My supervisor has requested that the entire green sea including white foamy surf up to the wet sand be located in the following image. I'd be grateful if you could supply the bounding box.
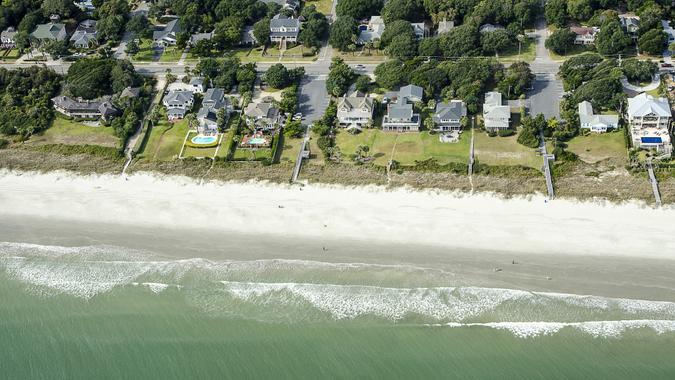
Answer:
[0,244,675,379]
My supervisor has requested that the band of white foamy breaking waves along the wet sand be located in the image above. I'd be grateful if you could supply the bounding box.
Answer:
[0,243,675,338]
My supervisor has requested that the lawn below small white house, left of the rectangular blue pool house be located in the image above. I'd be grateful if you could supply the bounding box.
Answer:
[567,130,628,164]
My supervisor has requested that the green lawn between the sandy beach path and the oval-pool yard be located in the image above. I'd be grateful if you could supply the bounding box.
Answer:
[140,119,188,161]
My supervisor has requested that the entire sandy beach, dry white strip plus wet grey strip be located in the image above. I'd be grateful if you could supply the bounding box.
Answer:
[0,172,675,301]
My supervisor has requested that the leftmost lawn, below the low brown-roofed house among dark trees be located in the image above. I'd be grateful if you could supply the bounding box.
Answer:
[30,117,119,147]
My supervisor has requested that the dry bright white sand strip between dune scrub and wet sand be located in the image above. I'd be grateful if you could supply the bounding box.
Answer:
[0,170,675,260]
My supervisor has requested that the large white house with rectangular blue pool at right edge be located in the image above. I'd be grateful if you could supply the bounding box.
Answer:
[628,93,673,154]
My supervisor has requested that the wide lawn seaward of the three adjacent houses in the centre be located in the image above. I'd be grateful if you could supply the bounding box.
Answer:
[336,129,471,165]
